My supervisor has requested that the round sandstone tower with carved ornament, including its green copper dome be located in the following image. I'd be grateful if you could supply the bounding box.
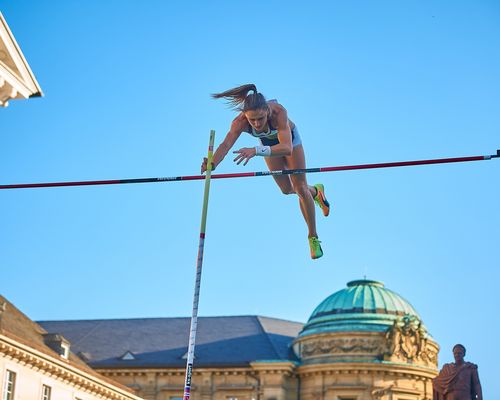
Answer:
[293,280,439,400]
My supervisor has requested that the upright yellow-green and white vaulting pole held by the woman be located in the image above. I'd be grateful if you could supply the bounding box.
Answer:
[184,130,215,400]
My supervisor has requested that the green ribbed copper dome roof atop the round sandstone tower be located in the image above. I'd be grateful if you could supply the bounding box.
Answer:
[299,279,420,336]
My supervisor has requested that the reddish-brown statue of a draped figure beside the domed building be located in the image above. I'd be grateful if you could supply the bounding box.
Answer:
[433,344,483,400]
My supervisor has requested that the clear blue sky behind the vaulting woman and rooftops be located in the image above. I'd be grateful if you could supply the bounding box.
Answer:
[0,0,500,399]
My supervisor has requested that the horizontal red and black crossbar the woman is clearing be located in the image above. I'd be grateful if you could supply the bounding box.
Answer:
[0,150,500,189]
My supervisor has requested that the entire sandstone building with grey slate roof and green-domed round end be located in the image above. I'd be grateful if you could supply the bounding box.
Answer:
[32,280,439,400]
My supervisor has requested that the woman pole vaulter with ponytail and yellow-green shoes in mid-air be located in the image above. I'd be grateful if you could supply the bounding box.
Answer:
[201,84,330,259]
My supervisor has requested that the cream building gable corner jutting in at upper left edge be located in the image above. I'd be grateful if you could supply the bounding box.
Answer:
[0,13,42,107]
